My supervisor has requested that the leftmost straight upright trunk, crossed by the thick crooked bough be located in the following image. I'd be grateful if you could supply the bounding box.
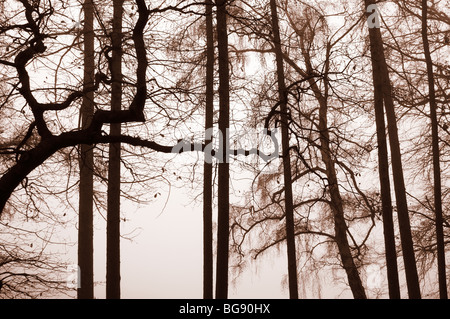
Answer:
[77,0,95,299]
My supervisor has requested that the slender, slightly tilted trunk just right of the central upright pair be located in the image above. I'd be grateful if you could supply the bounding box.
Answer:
[270,0,298,299]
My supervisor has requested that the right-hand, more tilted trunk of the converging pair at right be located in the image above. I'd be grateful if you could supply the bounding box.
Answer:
[365,0,421,299]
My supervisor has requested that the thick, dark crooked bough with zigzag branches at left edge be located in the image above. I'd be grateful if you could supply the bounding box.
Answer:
[0,0,151,216]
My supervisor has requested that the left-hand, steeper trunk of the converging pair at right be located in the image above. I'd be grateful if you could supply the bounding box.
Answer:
[371,8,401,299]
